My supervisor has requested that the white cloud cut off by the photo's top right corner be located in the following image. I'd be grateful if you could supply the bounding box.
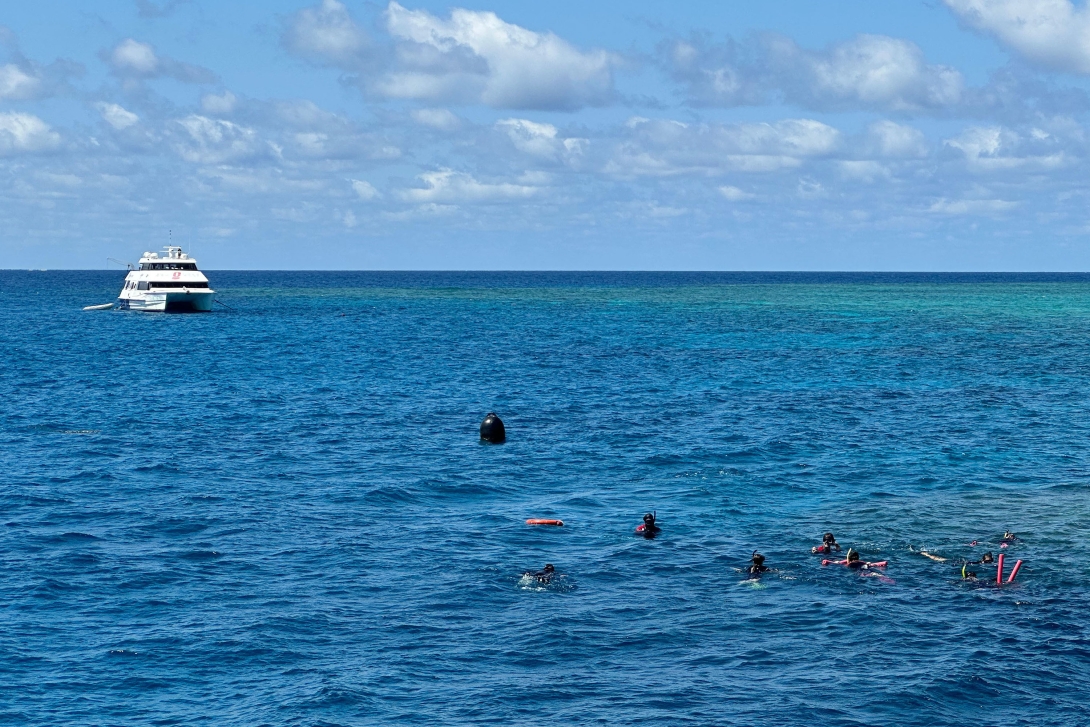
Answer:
[943,0,1090,73]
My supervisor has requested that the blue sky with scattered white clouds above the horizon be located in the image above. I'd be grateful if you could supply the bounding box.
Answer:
[0,0,1090,270]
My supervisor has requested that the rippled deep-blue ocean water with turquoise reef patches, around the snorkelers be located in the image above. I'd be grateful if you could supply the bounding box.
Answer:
[0,271,1090,727]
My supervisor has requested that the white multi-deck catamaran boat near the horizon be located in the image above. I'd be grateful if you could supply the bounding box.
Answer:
[118,245,216,313]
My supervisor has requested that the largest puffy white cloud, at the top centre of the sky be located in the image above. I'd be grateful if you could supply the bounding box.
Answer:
[377,2,614,109]
